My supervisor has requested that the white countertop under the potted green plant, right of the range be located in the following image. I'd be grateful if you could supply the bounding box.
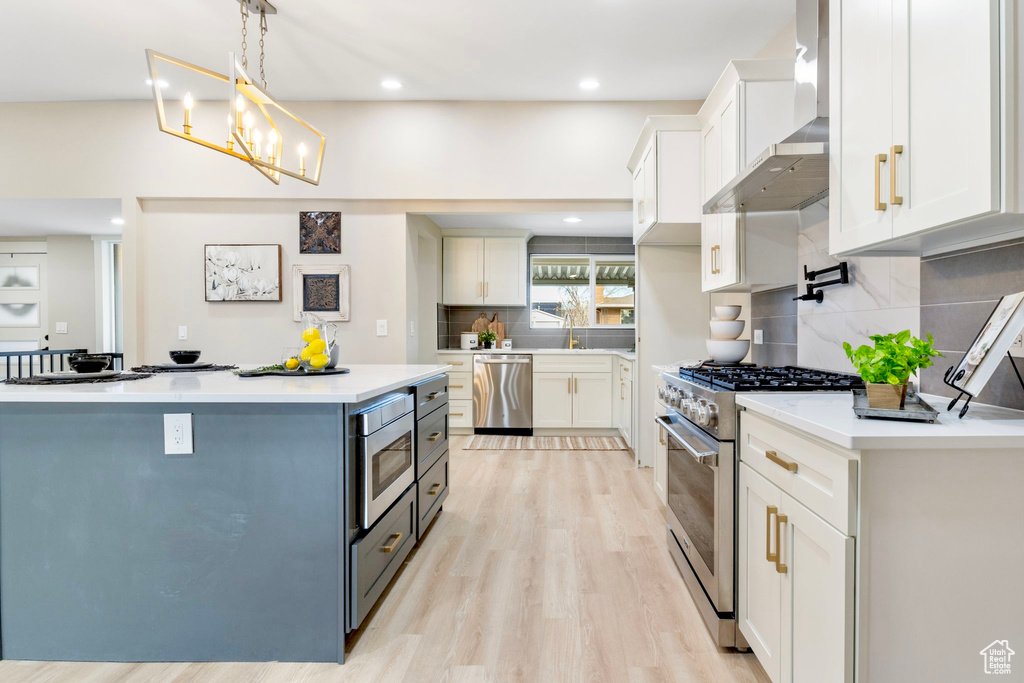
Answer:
[736,393,1024,451]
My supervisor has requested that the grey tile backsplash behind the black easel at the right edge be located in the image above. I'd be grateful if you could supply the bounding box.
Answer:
[921,240,1024,410]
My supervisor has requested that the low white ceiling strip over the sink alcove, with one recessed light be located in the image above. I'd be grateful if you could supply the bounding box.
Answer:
[427,211,633,238]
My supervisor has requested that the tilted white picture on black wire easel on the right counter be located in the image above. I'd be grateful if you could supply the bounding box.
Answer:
[948,292,1024,396]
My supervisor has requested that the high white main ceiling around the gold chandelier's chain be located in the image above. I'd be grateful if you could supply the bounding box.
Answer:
[0,0,794,101]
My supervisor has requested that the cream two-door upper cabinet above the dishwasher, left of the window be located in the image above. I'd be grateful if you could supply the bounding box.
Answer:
[441,237,526,306]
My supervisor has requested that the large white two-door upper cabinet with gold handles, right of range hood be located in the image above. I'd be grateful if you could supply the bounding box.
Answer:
[829,0,1011,254]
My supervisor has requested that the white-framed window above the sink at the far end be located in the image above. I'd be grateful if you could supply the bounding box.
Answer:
[529,255,636,329]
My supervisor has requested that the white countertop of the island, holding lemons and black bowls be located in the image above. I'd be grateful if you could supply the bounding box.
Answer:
[0,365,452,403]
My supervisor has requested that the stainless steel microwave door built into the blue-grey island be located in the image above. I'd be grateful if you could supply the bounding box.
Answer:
[358,413,416,528]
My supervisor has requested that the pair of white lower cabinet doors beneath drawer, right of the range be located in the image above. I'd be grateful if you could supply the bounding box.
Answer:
[738,462,854,683]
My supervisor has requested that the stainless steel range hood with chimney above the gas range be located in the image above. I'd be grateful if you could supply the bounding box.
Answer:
[703,0,828,213]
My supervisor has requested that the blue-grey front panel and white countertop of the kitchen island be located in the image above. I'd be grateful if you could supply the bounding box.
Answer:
[0,366,449,663]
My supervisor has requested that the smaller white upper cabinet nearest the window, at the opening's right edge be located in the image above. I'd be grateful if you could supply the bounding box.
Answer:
[627,116,701,245]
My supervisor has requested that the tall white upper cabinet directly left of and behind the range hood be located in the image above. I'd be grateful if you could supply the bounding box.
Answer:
[697,59,799,292]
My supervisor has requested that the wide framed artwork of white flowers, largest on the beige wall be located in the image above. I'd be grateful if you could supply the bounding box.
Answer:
[204,245,282,301]
